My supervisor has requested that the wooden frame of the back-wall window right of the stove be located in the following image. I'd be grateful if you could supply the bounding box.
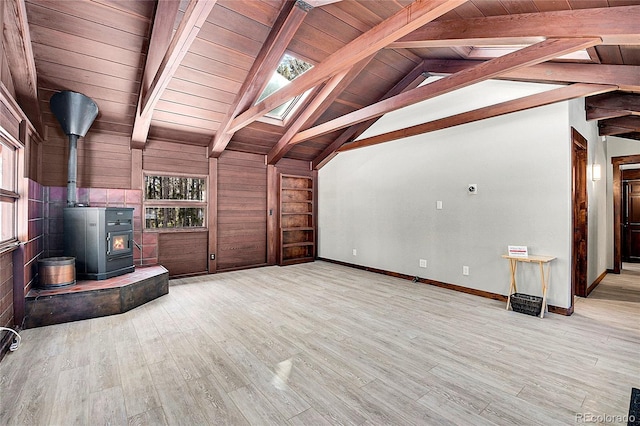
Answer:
[142,170,209,232]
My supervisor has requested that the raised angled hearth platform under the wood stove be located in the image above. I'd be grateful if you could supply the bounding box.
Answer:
[24,265,169,328]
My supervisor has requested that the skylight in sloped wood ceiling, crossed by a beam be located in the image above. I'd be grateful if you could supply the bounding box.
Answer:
[256,54,313,120]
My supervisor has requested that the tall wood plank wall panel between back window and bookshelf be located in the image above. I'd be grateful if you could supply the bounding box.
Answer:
[217,151,267,271]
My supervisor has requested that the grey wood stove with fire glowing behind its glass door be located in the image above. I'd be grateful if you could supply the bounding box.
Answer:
[64,207,134,280]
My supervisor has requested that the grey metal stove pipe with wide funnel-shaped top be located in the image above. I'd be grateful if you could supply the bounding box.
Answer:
[49,90,98,207]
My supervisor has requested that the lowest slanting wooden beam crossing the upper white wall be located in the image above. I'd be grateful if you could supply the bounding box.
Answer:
[338,83,618,152]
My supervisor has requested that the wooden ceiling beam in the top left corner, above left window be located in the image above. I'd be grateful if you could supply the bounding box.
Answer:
[0,0,43,135]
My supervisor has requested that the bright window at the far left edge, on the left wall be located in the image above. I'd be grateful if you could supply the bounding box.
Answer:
[0,137,19,246]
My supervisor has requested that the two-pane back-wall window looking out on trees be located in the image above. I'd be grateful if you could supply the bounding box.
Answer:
[144,175,207,229]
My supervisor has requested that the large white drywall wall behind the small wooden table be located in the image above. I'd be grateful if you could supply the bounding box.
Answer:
[318,81,571,307]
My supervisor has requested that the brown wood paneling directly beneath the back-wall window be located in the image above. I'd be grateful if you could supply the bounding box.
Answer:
[158,231,208,277]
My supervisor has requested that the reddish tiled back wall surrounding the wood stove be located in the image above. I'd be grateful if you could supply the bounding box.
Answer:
[44,186,158,265]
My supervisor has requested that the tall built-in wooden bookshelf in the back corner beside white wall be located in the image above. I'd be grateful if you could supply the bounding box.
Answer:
[279,174,316,265]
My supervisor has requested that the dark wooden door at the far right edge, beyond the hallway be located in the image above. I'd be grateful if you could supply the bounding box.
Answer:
[622,180,640,262]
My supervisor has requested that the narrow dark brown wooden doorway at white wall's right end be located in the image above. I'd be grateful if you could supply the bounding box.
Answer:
[569,127,589,302]
